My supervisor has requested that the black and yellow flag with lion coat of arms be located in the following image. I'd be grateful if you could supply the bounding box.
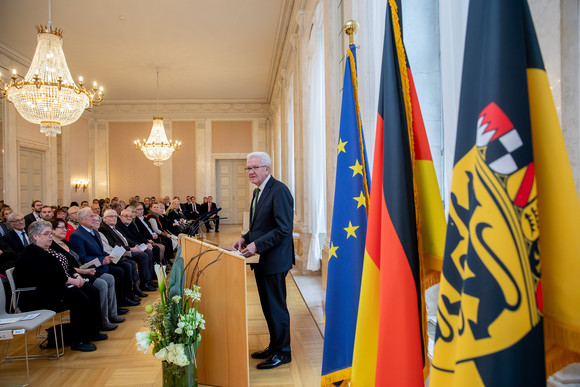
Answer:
[431,0,580,387]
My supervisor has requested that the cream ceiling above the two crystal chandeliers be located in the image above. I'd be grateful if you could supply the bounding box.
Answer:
[0,0,294,103]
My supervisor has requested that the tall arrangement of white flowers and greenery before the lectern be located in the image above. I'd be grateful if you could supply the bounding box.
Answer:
[136,246,221,386]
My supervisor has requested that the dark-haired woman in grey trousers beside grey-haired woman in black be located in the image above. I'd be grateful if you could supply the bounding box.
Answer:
[50,218,125,331]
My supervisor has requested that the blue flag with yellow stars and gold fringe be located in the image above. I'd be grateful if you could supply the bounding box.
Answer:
[321,45,370,386]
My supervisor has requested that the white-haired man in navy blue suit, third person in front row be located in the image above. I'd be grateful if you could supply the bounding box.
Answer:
[69,207,139,306]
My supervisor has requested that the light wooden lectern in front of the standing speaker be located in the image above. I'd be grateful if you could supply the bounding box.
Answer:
[180,234,250,386]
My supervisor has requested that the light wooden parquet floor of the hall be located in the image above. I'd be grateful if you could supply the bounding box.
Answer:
[0,225,323,387]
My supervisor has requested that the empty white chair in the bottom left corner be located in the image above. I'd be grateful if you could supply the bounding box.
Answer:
[0,283,60,386]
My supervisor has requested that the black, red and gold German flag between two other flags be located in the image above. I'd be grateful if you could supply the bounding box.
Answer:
[351,0,445,387]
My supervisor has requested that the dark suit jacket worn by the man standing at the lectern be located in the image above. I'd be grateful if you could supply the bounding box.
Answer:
[244,177,294,275]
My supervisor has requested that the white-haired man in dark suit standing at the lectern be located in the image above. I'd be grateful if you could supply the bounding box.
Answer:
[233,152,294,369]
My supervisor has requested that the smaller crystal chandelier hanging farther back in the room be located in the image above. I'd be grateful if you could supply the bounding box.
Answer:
[135,68,181,166]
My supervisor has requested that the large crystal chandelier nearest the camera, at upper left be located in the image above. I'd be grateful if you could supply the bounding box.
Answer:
[0,0,103,136]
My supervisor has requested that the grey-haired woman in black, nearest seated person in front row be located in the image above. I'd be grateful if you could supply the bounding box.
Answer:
[14,220,108,352]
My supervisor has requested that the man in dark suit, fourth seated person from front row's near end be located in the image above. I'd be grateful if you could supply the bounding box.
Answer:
[99,209,155,297]
